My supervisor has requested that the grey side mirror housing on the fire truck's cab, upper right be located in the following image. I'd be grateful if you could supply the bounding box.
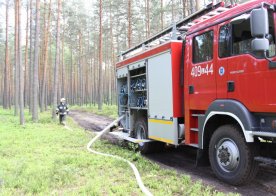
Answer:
[250,7,269,51]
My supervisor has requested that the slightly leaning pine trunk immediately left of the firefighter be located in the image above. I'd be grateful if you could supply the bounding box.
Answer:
[52,0,62,119]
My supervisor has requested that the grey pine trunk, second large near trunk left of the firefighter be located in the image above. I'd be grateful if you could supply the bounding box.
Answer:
[32,0,40,122]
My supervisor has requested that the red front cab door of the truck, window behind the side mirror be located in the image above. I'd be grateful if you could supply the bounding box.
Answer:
[227,11,276,112]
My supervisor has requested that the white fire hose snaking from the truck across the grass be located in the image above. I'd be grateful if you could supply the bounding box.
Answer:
[87,115,152,196]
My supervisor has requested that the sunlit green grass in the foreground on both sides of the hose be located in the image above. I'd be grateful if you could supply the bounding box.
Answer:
[0,109,235,195]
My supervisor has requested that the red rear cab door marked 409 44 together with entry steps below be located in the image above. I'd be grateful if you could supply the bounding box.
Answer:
[184,26,217,147]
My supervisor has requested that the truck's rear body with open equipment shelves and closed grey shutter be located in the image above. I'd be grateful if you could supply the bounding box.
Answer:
[117,41,184,145]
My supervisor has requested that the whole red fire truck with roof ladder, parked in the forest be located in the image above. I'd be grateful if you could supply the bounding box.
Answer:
[113,0,276,185]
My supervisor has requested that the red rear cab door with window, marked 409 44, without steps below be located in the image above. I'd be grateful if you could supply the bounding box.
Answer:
[187,27,216,110]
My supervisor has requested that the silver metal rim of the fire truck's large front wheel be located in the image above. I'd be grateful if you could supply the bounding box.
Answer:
[216,138,240,172]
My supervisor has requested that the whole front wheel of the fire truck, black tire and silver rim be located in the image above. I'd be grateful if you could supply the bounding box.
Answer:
[209,125,259,185]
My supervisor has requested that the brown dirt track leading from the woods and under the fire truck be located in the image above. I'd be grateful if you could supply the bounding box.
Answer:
[70,109,276,196]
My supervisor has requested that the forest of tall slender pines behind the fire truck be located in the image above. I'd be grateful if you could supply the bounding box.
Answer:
[0,0,248,124]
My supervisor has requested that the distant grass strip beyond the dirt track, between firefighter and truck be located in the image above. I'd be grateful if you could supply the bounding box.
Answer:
[70,104,118,119]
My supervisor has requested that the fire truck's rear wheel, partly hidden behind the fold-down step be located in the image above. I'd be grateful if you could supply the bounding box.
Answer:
[134,119,164,154]
